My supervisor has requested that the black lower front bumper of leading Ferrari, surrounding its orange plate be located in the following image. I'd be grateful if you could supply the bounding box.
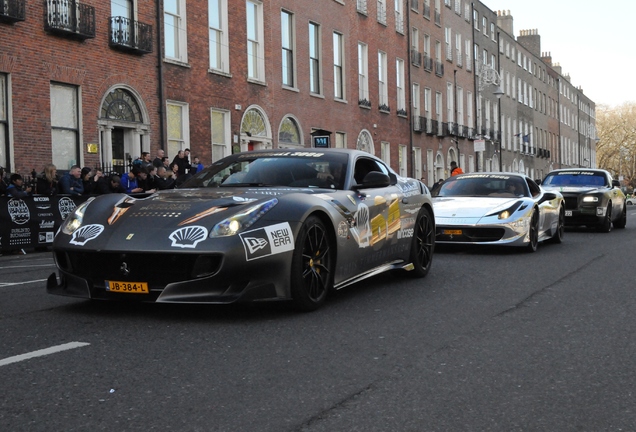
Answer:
[47,250,291,304]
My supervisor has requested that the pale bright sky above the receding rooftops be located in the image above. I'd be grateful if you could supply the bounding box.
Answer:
[481,0,636,106]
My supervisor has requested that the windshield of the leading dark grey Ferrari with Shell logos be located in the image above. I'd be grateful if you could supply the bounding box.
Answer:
[180,151,348,189]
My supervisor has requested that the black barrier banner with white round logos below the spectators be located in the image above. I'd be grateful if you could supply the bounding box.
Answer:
[0,195,89,251]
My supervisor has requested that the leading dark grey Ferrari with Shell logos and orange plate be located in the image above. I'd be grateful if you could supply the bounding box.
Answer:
[47,149,435,310]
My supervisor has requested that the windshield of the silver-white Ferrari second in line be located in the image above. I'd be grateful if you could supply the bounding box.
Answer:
[434,174,530,198]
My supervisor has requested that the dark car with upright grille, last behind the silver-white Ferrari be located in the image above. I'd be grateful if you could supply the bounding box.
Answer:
[541,168,627,232]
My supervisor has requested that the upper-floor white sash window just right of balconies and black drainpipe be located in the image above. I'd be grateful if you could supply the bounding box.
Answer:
[163,0,188,63]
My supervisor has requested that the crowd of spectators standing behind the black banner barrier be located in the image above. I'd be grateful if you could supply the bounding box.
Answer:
[0,149,203,198]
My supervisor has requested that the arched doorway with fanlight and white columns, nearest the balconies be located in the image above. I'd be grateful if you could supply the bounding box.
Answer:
[97,87,150,174]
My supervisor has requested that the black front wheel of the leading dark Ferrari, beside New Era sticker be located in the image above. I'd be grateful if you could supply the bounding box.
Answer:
[290,216,336,311]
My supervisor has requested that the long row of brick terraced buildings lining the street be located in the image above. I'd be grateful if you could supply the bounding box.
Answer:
[0,0,595,184]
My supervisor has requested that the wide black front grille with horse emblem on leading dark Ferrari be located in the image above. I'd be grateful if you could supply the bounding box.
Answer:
[56,251,222,288]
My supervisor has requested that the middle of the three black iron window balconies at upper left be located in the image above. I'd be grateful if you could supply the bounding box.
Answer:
[43,0,95,39]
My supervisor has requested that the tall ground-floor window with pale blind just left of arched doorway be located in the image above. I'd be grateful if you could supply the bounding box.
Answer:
[51,83,81,169]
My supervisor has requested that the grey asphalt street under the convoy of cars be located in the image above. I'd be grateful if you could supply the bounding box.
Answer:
[0,211,636,432]
